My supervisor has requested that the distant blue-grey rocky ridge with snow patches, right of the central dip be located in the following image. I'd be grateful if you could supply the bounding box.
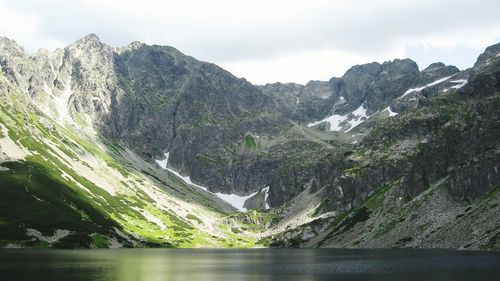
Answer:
[261,59,459,122]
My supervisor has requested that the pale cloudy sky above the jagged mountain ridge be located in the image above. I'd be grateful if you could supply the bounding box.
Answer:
[0,0,500,84]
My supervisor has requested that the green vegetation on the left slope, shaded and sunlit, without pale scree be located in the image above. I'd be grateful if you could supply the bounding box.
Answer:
[0,92,262,248]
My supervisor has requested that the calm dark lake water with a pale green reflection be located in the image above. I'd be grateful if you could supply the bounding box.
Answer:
[0,249,500,281]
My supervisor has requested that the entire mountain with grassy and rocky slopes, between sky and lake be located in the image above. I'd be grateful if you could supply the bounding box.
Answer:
[0,34,500,249]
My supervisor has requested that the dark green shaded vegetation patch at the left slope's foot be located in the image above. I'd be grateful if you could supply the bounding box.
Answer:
[0,162,121,247]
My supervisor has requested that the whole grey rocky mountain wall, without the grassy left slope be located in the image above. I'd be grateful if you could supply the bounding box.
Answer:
[0,34,500,248]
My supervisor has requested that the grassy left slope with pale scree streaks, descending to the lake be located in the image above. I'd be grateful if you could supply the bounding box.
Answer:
[0,80,256,248]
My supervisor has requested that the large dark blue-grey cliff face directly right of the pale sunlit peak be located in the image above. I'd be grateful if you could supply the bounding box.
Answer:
[110,45,286,195]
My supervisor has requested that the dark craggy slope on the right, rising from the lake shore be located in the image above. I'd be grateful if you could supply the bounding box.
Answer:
[262,44,500,249]
